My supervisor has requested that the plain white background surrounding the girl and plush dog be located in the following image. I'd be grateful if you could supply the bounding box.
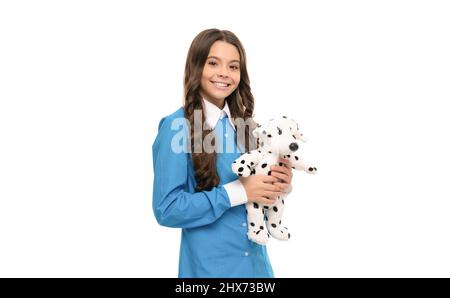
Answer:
[0,0,450,277]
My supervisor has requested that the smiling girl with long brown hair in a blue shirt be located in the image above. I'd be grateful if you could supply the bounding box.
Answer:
[152,29,292,277]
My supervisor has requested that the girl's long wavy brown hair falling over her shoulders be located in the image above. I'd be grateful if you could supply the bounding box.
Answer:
[183,29,254,191]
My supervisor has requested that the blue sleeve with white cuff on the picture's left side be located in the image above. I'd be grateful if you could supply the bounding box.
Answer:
[152,118,246,228]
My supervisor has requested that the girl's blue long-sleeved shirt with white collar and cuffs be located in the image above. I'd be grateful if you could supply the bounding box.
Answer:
[152,104,273,277]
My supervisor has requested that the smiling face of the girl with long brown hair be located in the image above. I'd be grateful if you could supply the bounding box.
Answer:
[200,41,241,105]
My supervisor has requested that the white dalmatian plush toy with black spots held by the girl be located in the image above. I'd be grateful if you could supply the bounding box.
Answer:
[232,116,317,245]
